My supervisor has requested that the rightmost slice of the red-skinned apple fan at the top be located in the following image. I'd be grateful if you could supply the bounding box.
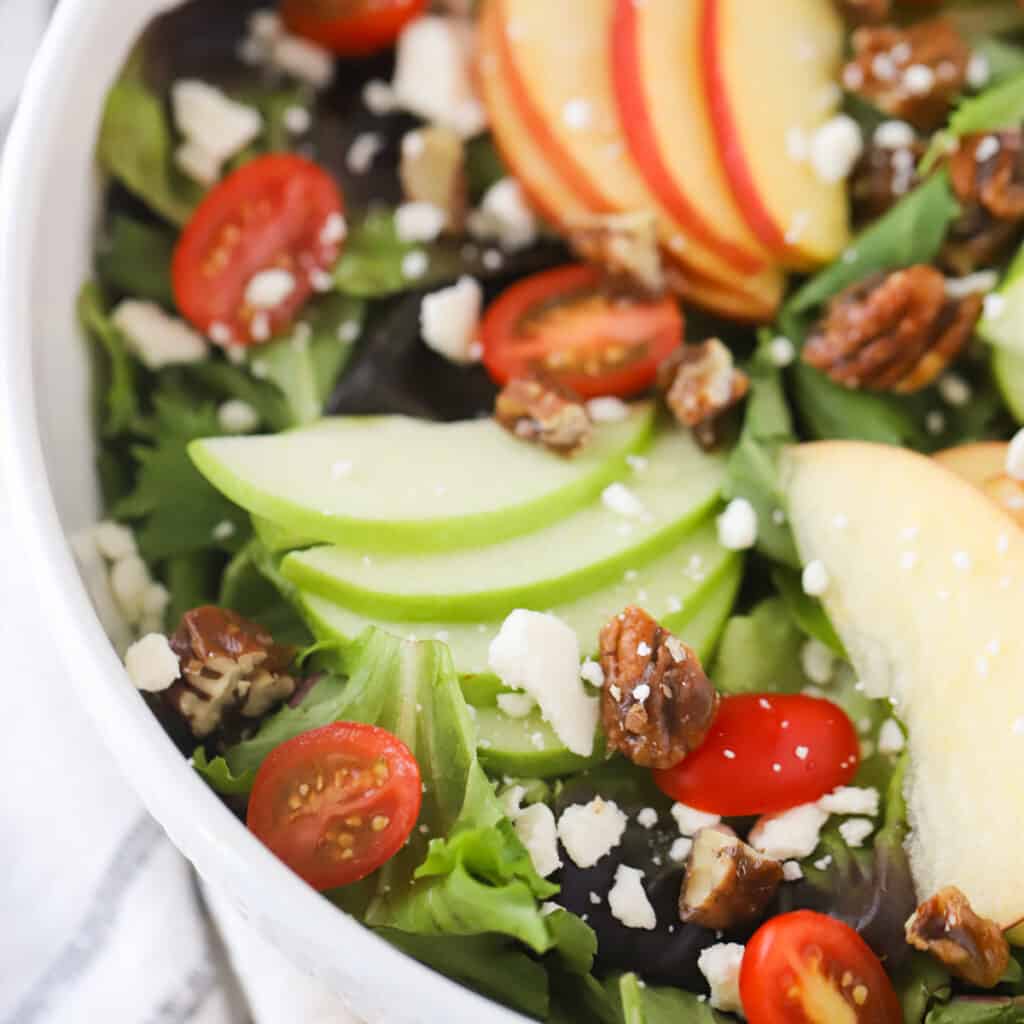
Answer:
[700,0,849,269]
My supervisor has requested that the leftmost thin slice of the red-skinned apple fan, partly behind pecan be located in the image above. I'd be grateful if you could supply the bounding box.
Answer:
[479,3,779,322]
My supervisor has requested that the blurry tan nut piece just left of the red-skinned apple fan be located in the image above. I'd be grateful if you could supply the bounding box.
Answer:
[398,125,469,231]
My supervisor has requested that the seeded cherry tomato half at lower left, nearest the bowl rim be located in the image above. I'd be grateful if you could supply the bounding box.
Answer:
[246,722,422,891]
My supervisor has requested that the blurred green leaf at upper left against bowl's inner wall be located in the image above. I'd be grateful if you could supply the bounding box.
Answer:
[96,66,203,225]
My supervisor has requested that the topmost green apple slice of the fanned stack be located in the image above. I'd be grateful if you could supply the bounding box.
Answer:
[188,402,654,552]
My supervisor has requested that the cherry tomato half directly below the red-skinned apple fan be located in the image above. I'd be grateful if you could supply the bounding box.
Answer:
[480,266,683,398]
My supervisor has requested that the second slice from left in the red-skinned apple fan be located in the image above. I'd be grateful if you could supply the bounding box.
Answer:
[496,0,782,313]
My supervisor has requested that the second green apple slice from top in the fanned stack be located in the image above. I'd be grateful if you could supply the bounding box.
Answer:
[281,430,725,622]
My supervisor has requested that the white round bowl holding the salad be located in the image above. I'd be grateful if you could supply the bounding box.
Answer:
[0,0,525,1024]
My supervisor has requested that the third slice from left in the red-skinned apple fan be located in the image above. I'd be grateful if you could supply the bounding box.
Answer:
[611,0,770,273]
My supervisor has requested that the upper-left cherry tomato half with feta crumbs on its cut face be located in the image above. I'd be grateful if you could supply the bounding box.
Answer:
[171,154,345,345]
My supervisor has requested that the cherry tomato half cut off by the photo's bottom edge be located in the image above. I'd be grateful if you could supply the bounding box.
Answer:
[739,910,903,1024]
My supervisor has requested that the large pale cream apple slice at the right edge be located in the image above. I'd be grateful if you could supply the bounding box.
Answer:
[782,441,1024,928]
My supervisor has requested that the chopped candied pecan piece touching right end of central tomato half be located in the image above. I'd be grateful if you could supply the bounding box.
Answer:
[657,338,751,449]
